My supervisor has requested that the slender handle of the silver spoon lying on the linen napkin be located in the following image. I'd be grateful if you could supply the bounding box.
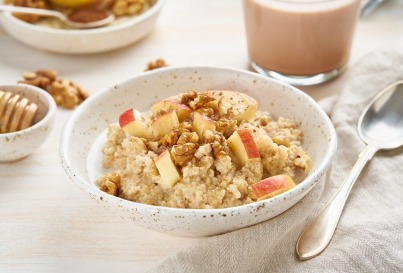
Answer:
[296,146,378,260]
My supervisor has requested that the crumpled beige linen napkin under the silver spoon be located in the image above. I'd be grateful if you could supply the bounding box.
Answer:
[151,45,403,273]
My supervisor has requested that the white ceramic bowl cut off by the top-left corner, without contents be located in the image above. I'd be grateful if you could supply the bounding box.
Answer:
[0,0,165,54]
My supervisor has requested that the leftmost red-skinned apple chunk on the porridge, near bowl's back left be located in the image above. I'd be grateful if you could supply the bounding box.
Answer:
[119,108,153,139]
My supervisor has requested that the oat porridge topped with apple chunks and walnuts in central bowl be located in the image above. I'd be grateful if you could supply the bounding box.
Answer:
[97,90,311,209]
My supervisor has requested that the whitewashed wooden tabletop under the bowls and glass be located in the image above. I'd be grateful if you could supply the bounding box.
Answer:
[0,0,403,272]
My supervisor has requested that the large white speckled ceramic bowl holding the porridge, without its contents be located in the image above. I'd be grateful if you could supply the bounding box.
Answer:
[60,67,337,237]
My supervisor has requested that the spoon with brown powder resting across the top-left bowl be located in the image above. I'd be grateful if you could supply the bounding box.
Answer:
[0,5,115,29]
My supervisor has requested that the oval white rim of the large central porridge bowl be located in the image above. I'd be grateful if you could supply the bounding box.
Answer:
[59,65,337,216]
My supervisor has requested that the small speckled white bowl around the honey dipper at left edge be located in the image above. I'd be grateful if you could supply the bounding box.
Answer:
[0,84,56,162]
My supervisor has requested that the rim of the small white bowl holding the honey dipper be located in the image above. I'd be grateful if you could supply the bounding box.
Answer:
[0,83,57,135]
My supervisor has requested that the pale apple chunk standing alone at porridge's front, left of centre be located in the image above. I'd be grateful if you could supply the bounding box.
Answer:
[154,150,181,188]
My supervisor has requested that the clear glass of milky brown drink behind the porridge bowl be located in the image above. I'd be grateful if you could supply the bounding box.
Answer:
[243,0,360,85]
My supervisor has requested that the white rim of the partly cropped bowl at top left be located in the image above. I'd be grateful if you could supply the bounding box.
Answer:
[0,0,166,36]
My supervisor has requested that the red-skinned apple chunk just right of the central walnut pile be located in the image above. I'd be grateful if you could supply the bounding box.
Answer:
[227,129,260,165]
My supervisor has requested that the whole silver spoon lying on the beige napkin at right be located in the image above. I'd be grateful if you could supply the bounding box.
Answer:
[296,81,403,260]
